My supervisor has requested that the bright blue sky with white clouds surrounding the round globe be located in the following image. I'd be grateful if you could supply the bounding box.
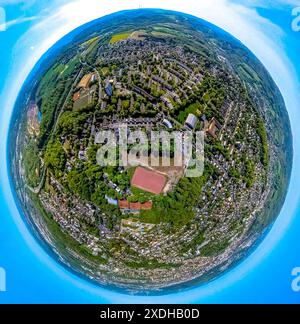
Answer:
[0,0,300,303]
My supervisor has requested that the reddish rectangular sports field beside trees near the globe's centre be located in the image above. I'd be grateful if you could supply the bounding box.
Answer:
[131,167,167,195]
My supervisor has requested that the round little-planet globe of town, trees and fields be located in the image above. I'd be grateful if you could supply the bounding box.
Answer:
[10,9,293,294]
